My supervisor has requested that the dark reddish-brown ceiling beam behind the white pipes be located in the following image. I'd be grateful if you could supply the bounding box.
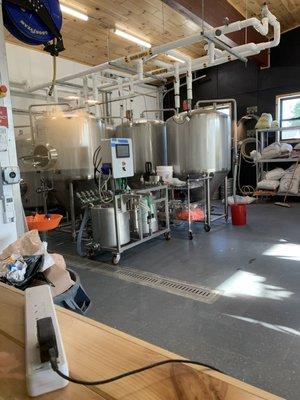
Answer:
[162,0,269,67]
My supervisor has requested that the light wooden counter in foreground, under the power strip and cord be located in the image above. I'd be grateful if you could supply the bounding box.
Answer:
[0,283,279,400]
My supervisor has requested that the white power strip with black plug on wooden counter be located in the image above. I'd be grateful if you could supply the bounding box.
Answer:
[25,285,69,396]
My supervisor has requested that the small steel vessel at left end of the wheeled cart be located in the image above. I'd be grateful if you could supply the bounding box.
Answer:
[91,206,130,247]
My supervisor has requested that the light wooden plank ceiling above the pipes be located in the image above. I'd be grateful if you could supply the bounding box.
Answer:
[7,0,300,65]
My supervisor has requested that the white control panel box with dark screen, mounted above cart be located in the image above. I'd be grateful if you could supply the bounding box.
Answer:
[101,138,134,179]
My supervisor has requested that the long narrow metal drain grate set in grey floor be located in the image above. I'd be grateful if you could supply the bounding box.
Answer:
[65,256,220,304]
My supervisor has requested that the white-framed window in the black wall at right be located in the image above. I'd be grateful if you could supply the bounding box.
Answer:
[277,93,300,140]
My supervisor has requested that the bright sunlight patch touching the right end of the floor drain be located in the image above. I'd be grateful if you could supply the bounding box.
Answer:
[217,271,294,300]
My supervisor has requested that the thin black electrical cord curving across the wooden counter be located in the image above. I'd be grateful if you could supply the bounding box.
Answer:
[49,349,224,386]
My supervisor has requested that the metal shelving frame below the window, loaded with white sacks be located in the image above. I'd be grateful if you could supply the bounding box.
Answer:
[255,126,300,197]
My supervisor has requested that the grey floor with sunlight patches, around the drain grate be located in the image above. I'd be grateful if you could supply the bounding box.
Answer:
[50,203,300,400]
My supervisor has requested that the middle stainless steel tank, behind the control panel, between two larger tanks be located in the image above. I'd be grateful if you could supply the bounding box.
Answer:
[116,120,166,174]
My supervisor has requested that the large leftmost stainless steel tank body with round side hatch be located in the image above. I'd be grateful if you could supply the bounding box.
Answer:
[34,111,105,180]
